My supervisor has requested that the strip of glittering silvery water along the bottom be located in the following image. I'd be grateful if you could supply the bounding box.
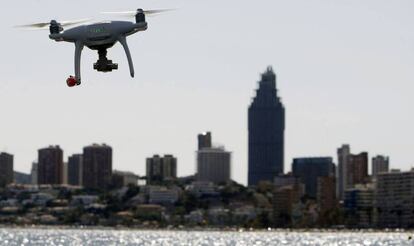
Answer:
[0,229,414,246]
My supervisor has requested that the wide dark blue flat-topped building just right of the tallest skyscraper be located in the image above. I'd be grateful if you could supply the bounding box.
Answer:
[292,157,335,199]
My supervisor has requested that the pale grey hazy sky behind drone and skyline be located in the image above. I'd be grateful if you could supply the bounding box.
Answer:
[0,0,414,183]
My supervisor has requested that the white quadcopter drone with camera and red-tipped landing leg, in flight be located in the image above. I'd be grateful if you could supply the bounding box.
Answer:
[17,9,169,87]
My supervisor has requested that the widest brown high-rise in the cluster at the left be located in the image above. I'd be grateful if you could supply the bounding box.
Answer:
[82,144,112,189]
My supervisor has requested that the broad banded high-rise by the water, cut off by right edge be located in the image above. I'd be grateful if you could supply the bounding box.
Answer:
[375,170,414,228]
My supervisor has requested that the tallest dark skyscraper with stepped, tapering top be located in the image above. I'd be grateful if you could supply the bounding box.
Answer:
[248,67,285,185]
